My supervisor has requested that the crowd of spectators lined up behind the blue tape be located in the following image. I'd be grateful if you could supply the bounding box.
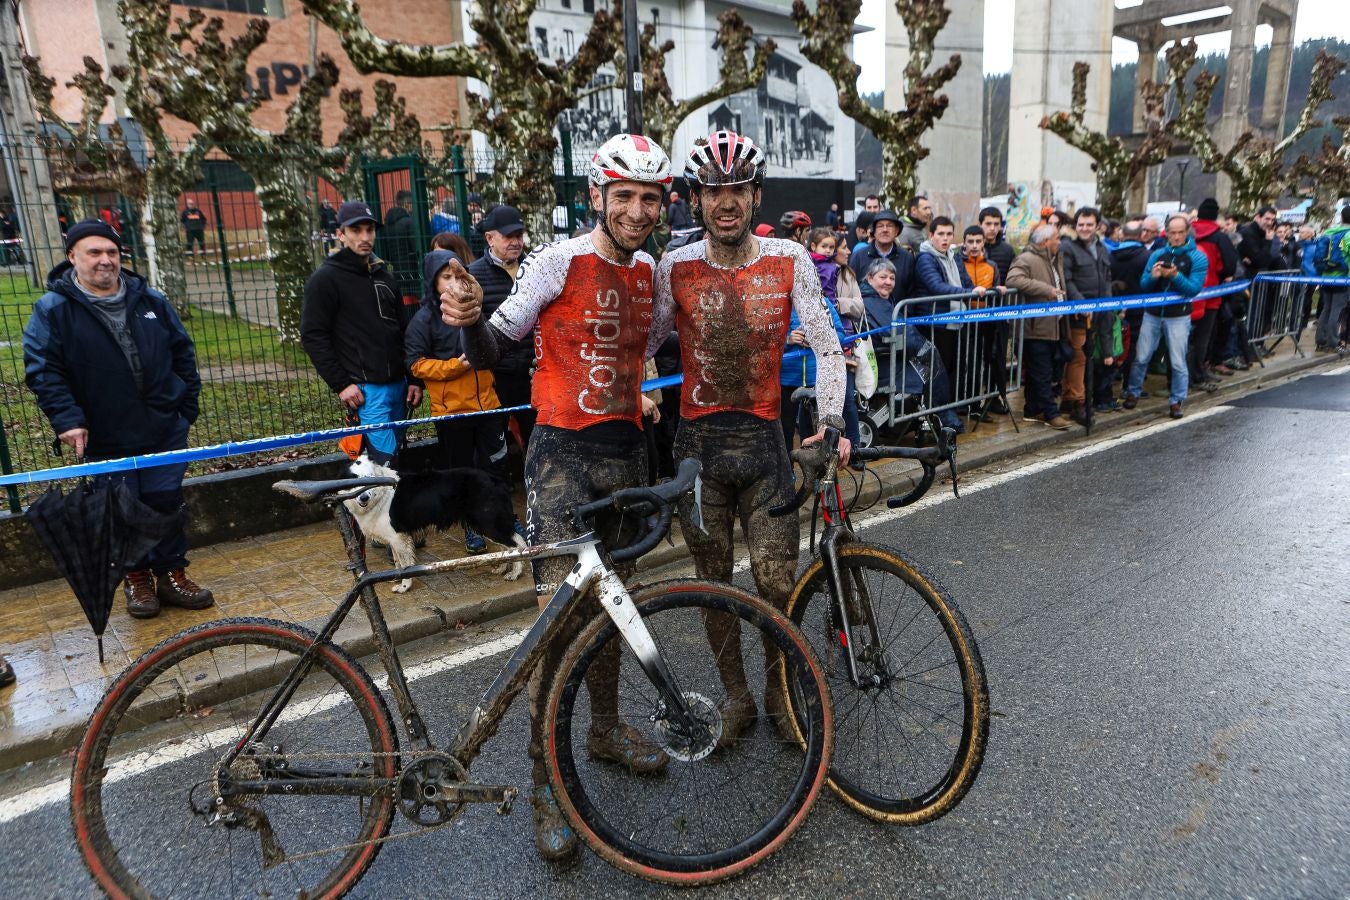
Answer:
[0,156,1350,684]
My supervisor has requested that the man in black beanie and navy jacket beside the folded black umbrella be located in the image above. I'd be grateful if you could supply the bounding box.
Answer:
[23,219,215,618]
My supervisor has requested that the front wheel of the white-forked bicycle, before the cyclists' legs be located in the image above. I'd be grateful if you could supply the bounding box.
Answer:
[551,588,825,874]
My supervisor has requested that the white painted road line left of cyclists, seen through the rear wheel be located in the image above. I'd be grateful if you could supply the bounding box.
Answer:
[0,629,528,824]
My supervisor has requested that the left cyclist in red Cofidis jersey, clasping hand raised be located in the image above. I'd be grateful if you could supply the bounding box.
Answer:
[441,135,672,860]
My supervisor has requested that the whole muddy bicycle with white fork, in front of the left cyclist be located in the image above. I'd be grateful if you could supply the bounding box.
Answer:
[70,461,833,897]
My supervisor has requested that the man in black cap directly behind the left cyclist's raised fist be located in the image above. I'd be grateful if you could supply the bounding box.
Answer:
[468,206,535,447]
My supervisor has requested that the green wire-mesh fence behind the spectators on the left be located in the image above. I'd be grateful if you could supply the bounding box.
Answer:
[0,135,590,511]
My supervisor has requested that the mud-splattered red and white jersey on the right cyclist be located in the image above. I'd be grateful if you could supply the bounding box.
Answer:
[647,237,846,420]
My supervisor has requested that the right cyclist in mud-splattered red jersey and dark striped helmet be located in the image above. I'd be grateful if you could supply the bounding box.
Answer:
[647,131,851,743]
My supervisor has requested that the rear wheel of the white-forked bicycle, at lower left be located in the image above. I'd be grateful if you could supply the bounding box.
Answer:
[70,619,398,897]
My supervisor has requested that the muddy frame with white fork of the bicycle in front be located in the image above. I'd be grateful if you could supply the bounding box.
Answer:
[217,498,698,801]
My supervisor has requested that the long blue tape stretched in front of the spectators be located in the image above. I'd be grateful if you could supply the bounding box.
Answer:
[0,274,1350,487]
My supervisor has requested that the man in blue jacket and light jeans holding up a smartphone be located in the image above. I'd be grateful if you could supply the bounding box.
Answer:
[1123,215,1210,418]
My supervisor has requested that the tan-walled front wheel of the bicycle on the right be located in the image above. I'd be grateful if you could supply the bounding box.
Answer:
[787,544,990,824]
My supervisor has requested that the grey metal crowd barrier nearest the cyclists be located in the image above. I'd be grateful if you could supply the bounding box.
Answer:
[864,290,1026,439]
